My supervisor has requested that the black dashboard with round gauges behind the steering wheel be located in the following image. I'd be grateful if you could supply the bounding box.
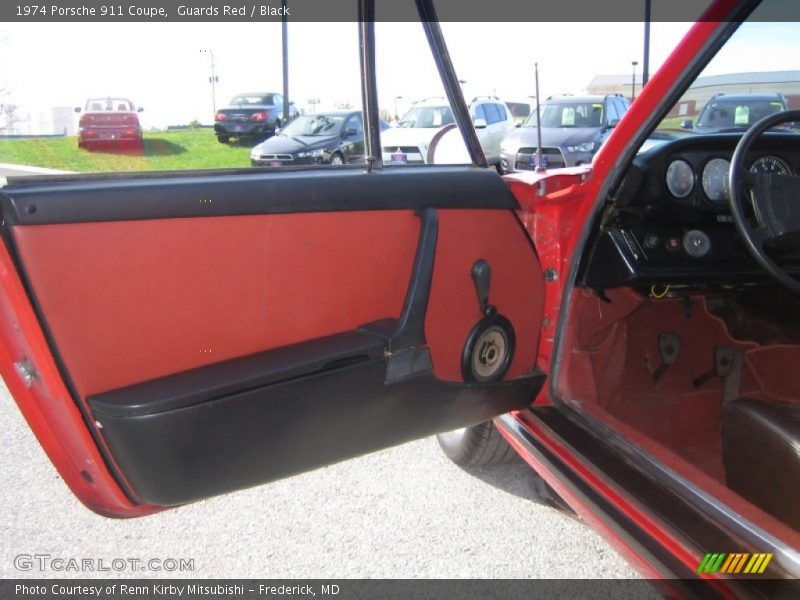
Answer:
[582,133,800,289]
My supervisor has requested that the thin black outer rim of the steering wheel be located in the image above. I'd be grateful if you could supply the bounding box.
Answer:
[728,110,800,295]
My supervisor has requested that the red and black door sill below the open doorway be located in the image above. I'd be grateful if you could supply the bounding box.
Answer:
[496,404,800,596]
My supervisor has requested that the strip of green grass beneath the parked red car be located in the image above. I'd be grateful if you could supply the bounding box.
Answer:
[0,129,251,173]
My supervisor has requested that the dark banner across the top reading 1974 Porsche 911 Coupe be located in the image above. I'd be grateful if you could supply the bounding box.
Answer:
[0,0,800,23]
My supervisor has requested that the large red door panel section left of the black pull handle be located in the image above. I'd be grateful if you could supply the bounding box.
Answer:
[14,211,419,397]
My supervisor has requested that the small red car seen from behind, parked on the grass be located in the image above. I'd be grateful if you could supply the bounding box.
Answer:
[75,96,142,148]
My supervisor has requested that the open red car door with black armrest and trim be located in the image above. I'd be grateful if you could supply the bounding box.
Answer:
[0,4,544,516]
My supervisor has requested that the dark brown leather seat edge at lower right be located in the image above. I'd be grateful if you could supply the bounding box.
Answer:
[722,398,800,530]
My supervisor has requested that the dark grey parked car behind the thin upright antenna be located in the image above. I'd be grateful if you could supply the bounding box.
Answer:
[500,94,630,173]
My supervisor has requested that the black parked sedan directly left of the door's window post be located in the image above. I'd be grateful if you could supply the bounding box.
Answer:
[250,111,389,167]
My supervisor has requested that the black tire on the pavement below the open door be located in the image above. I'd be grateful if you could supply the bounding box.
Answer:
[436,421,517,467]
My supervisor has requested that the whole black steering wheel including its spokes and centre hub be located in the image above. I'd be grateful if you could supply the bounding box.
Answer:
[728,110,800,295]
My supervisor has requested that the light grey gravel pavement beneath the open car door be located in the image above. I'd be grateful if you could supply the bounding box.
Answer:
[0,386,638,578]
